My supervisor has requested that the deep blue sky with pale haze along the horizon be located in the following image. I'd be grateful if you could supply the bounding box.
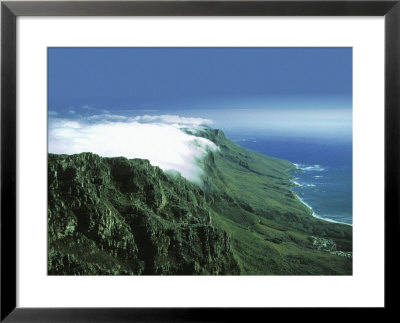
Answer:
[48,48,352,136]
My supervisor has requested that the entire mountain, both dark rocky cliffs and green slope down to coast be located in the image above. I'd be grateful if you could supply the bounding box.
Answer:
[48,129,352,275]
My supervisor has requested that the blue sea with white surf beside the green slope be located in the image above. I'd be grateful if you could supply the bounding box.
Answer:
[227,134,353,224]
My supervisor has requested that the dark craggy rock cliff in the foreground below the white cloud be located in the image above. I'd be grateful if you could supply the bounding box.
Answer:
[48,153,239,275]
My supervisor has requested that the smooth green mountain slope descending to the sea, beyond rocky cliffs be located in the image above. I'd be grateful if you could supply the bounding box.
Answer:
[197,130,352,275]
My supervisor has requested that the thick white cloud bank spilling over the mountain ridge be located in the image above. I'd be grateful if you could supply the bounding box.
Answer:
[49,114,218,184]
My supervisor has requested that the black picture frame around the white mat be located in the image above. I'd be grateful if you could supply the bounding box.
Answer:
[0,0,400,322]
